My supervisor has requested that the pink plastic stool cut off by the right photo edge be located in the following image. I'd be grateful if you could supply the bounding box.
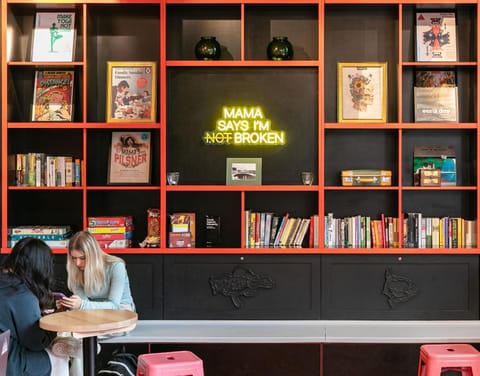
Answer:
[418,343,480,376]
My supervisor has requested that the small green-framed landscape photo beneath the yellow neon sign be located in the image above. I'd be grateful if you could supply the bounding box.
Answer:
[226,158,262,185]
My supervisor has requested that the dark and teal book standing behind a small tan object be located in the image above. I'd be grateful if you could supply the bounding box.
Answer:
[413,145,457,186]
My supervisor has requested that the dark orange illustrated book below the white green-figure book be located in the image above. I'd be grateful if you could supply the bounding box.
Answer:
[31,70,74,121]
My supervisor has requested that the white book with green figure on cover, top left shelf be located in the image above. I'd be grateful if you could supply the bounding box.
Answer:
[32,12,75,62]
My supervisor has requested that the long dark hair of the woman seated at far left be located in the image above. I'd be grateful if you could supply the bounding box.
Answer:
[3,238,54,309]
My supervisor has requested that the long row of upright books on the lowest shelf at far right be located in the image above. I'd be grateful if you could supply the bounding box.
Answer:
[324,213,477,248]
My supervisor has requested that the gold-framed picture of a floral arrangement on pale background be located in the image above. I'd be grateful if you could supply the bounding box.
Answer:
[337,62,387,123]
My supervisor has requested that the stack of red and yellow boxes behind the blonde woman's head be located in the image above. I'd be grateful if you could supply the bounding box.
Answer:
[87,215,134,248]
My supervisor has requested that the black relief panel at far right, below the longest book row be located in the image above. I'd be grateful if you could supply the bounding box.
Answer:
[321,254,479,320]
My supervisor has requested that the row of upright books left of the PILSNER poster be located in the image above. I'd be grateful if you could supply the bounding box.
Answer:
[8,153,82,187]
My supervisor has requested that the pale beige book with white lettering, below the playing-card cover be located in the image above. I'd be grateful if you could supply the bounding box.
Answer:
[413,86,458,123]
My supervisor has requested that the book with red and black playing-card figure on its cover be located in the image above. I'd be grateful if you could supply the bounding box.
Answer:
[416,12,457,61]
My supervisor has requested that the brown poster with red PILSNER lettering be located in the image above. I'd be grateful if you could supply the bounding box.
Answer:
[108,131,151,184]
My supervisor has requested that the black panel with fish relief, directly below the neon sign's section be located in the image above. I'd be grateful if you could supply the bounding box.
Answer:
[164,255,320,319]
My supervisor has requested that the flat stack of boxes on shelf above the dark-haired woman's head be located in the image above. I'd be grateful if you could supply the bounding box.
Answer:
[7,225,73,248]
